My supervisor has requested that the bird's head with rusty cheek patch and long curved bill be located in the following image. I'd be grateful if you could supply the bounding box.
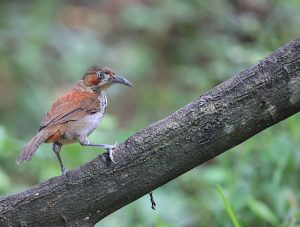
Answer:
[82,66,132,91]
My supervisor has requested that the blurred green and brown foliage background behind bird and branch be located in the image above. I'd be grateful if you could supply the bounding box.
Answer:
[0,0,300,227]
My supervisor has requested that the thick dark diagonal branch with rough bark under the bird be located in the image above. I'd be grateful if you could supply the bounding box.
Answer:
[0,39,300,226]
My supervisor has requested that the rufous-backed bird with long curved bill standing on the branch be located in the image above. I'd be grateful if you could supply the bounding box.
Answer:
[16,66,132,175]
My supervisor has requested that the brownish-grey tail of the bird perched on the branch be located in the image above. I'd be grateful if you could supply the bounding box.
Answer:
[16,130,49,164]
